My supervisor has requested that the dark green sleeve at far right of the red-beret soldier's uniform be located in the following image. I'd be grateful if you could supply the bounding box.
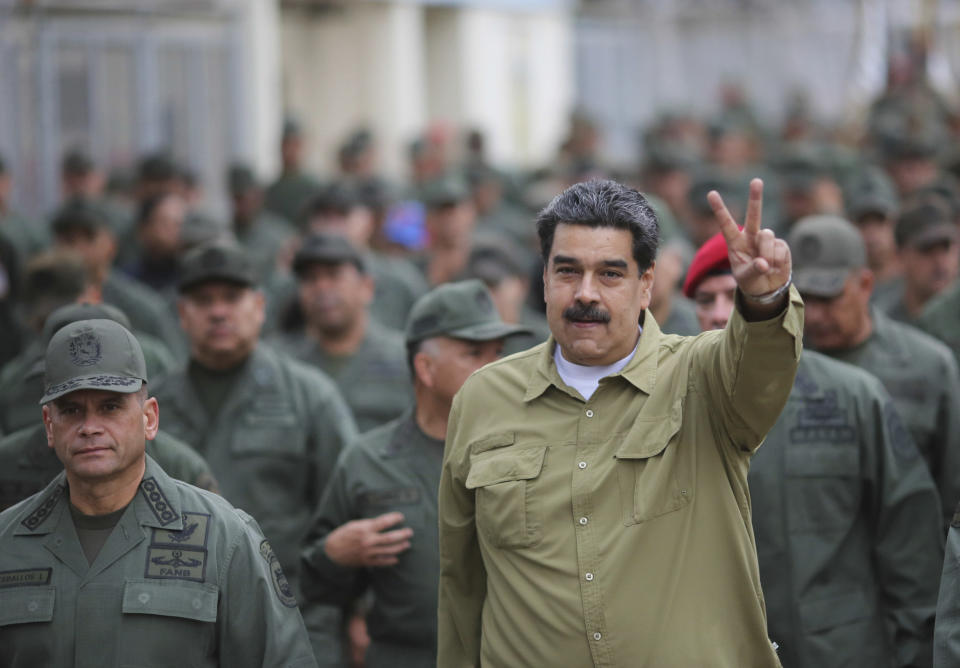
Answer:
[861,383,943,666]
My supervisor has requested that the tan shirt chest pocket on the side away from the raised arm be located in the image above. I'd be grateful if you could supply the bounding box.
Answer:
[466,434,547,548]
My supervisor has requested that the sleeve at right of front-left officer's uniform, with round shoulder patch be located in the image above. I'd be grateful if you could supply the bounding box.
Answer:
[217,511,317,668]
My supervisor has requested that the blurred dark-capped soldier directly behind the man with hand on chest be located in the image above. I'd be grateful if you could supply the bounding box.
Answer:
[280,233,413,432]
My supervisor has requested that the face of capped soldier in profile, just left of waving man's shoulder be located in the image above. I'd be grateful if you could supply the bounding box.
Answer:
[414,336,503,403]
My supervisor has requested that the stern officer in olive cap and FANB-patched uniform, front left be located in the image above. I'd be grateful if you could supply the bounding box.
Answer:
[0,320,316,668]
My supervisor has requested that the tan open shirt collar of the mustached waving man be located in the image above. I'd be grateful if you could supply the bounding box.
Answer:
[523,309,661,402]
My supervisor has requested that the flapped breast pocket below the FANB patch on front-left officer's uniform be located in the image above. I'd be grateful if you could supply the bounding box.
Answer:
[116,580,219,666]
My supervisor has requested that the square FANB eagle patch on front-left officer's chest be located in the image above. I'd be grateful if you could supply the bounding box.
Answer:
[144,512,210,582]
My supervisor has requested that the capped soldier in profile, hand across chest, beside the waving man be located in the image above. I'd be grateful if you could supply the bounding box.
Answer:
[303,281,525,668]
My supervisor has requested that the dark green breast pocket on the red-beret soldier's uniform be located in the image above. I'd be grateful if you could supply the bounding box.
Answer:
[785,445,860,532]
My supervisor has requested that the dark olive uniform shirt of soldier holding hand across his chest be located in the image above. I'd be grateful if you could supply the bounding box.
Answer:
[302,411,443,668]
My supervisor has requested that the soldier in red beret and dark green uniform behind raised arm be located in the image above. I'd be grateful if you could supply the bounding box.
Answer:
[685,234,943,668]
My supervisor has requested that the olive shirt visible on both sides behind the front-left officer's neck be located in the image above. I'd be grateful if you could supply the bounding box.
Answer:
[0,421,219,510]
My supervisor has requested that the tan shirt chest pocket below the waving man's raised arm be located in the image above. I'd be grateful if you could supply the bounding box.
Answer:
[614,403,693,526]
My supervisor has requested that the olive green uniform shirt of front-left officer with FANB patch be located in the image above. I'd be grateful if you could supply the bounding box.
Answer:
[0,457,316,668]
